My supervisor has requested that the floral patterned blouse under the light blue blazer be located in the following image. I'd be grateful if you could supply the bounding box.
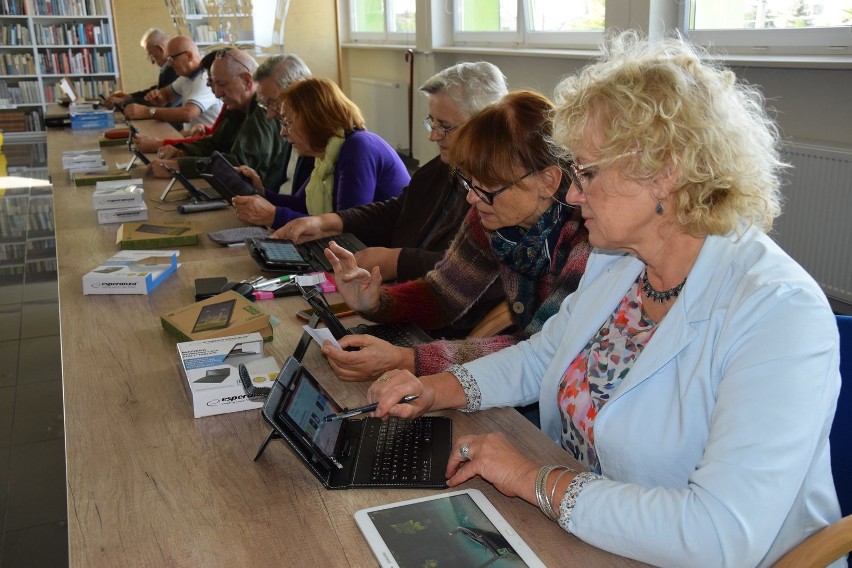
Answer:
[557,276,657,474]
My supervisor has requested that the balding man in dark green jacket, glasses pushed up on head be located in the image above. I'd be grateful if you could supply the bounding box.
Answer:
[148,49,287,187]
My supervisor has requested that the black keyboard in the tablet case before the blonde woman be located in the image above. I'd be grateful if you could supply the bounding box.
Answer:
[364,416,432,483]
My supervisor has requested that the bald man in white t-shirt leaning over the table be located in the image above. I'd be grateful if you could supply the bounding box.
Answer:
[124,36,222,132]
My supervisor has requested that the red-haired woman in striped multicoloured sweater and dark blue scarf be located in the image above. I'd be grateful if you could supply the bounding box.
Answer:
[322,91,591,381]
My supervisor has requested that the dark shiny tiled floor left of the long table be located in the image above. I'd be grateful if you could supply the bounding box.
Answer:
[0,140,68,568]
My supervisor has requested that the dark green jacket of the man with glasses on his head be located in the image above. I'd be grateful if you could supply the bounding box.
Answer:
[176,97,287,189]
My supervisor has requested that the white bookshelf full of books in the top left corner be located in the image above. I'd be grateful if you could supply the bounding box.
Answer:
[0,0,118,136]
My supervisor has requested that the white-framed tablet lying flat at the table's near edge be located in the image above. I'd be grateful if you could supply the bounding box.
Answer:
[355,489,544,568]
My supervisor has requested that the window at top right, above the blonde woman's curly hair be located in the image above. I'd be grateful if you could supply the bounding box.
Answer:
[682,0,852,54]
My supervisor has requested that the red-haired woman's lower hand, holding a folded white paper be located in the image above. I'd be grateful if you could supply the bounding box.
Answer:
[322,334,414,381]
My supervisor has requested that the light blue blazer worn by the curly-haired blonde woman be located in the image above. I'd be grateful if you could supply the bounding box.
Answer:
[465,228,845,567]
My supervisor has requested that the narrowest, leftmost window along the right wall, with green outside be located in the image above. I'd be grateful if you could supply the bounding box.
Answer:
[349,0,417,41]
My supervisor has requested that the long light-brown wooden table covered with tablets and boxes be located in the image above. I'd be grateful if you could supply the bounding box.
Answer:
[48,122,638,567]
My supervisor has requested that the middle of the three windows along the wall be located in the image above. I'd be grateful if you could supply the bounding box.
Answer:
[453,0,606,48]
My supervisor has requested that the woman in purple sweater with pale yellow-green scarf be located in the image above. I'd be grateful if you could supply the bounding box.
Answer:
[234,78,410,229]
